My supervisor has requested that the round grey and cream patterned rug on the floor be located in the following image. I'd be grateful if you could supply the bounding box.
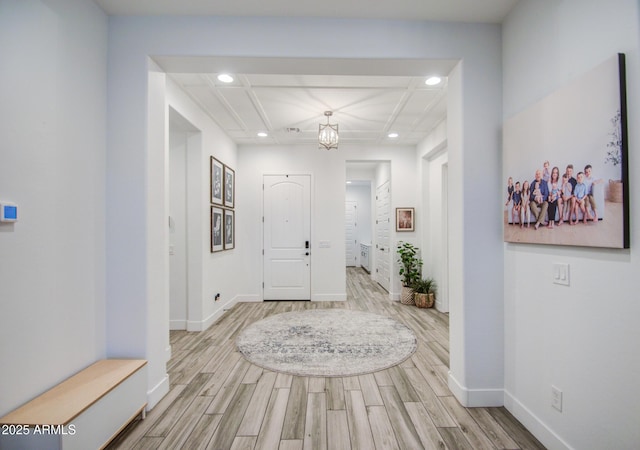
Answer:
[236,309,417,377]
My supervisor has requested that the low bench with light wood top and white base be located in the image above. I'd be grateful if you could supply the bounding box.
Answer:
[0,359,147,450]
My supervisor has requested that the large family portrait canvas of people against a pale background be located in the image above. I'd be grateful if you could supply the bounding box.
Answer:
[499,54,630,248]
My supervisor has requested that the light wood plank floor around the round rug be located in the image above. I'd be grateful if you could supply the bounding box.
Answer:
[108,268,544,450]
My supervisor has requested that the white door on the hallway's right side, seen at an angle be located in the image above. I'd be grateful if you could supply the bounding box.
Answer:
[375,181,391,292]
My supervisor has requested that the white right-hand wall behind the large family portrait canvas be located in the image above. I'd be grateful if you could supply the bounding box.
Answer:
[496,0,640,449]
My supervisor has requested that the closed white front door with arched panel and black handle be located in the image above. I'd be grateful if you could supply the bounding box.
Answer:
[263,175,311,300]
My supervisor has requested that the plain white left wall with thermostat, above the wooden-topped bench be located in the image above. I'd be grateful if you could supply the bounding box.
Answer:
[0,0,107,416]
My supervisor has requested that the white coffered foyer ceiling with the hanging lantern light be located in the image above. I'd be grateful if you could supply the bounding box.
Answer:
[171,73,447,144]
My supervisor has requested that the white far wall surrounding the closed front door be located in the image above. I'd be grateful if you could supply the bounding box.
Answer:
[236,145,424,301]
